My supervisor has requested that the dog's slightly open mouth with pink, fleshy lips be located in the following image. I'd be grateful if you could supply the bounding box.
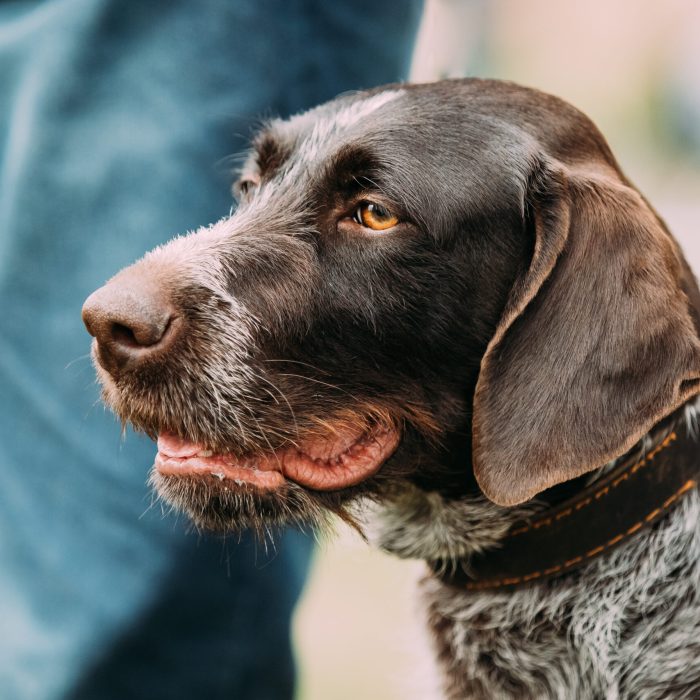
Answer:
[154,427,400,491]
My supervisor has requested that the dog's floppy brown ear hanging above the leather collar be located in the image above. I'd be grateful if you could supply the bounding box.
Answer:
[473,163,700,506]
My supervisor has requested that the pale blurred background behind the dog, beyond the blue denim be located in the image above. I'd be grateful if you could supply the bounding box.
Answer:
[294,0,700,700]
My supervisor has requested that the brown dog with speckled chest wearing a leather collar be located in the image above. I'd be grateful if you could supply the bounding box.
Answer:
[83,79,700,699]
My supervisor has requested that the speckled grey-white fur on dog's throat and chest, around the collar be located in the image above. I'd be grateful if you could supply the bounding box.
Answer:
[375,403,700,700]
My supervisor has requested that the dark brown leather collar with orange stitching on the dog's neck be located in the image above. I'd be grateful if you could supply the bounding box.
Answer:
[430,410,700,591]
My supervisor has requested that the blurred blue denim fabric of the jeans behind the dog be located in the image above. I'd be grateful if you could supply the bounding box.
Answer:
[0,0,421,700]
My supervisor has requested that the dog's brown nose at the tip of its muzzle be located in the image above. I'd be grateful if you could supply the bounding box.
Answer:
[83,277,175,375]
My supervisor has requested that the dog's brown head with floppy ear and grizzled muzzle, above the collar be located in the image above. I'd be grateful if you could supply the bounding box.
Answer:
[83,80,700,529]
